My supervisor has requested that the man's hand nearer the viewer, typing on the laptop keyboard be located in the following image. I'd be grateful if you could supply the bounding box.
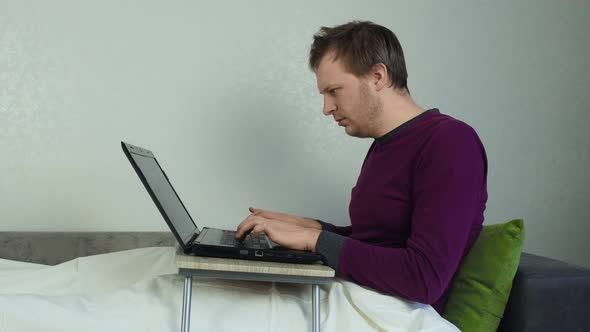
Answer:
[236,213,321,252]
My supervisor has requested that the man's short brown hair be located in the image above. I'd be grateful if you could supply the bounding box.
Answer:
[309,21,409,91]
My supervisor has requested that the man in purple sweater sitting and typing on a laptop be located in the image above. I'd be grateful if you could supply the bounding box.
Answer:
[236,21,487,313]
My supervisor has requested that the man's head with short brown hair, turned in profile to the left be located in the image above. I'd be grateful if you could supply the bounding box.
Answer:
[309,21,409,137]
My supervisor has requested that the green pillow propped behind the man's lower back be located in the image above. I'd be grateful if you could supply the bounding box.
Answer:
[442,219,524,332]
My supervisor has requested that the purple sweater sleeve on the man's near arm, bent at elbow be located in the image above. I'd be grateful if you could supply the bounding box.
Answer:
[337,122,487,304]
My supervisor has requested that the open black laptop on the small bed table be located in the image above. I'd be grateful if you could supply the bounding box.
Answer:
[121,142,322,264]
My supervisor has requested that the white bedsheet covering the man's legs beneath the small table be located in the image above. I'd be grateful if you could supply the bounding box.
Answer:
[0,248,459,332]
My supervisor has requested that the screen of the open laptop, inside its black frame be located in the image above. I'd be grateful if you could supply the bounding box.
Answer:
[128,147,199,245]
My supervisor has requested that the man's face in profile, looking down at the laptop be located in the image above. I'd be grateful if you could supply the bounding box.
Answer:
[316,53,383,137]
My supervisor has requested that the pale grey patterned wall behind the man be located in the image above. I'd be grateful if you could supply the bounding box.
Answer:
[0,0,590,267]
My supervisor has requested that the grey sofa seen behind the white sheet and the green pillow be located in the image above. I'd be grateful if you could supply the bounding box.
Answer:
[0,232,590,332]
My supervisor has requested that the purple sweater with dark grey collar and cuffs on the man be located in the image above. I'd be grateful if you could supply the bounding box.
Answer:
[316,109,487,313]
